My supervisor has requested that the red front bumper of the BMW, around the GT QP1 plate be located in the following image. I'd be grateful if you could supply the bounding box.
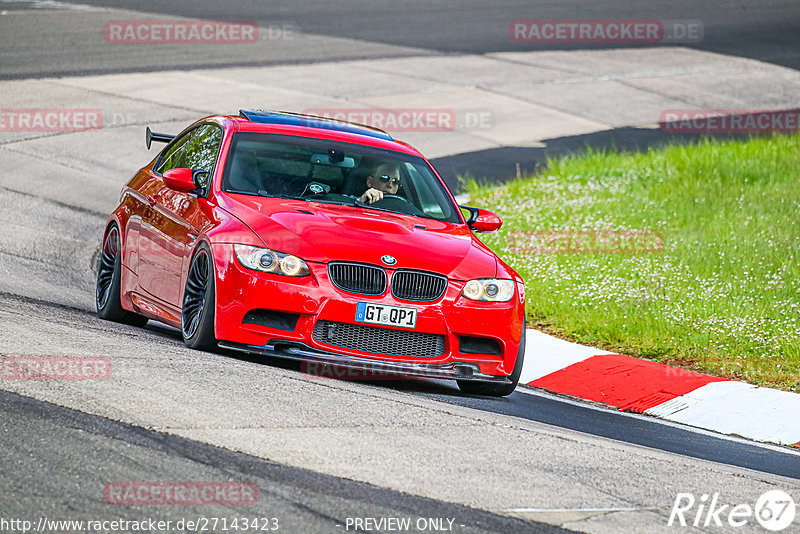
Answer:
[213,244,524,382]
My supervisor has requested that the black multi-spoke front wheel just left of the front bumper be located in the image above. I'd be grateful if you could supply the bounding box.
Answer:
[181,243,217,350]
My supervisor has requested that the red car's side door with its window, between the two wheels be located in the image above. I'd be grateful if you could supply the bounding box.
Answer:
[139,123,222,311]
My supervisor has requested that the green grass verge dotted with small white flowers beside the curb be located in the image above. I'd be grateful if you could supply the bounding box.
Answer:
[468,135,800,391]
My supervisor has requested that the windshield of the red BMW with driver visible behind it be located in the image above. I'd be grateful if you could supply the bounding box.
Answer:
[222,133,461,223]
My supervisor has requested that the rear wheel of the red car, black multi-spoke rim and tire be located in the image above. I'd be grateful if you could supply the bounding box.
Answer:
[94,224,147,326]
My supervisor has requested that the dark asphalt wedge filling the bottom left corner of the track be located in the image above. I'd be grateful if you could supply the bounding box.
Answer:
[0,391,564,533]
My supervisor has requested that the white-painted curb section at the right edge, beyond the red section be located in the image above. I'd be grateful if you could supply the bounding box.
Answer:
[645,381,800,445]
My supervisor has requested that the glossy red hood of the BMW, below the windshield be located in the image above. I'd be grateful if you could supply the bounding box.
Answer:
[220,195,497,280]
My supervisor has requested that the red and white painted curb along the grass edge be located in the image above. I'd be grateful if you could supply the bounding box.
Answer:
[520,329,800,447]
